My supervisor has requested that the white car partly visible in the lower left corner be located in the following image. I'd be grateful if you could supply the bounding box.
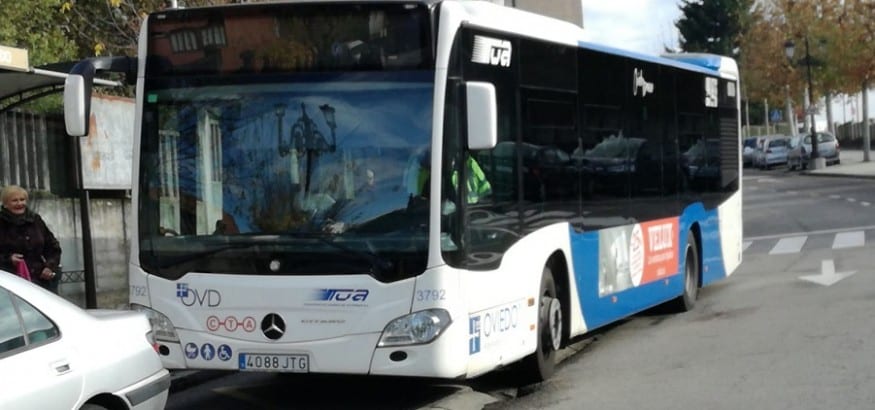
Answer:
[0,271,170,410]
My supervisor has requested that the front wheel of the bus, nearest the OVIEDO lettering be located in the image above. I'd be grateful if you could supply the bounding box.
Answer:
[516,266,562,384]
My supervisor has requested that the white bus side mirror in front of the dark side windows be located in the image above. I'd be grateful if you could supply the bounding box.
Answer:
[465,82,498,150]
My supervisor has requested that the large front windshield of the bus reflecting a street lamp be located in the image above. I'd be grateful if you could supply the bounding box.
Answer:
[139,70,434,278]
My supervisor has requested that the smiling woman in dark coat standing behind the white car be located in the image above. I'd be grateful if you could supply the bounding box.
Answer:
[0,185,61,293]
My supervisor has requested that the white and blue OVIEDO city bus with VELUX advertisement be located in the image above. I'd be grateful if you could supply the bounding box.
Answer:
[65,0,742,381]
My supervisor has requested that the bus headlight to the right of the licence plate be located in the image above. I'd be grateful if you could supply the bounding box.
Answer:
[377,309,452,347]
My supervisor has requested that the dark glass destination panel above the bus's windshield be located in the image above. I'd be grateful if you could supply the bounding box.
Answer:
[146,3,433,76]
